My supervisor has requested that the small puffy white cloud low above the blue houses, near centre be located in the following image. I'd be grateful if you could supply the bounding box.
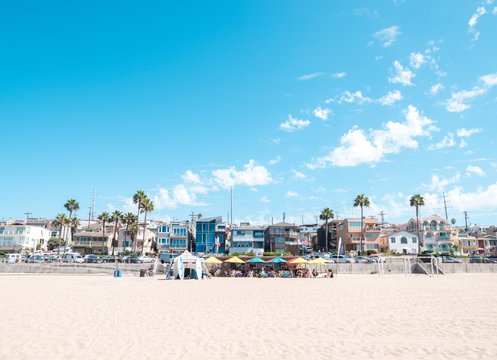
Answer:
[212,160,274,189]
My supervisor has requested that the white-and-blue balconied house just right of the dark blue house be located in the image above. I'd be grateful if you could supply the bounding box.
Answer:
[229,224,265,256]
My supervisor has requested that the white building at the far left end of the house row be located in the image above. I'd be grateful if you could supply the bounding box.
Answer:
[0,223,50,253]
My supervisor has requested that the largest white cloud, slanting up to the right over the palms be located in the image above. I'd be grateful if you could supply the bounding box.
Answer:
[307,105,438,169]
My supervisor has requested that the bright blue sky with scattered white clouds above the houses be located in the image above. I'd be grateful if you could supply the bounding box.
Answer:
[0,0,497,224]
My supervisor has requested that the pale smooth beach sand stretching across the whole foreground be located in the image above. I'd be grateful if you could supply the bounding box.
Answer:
[0,274,497,359]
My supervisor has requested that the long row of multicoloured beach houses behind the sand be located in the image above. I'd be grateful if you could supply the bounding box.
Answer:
[0,215,497,255]
